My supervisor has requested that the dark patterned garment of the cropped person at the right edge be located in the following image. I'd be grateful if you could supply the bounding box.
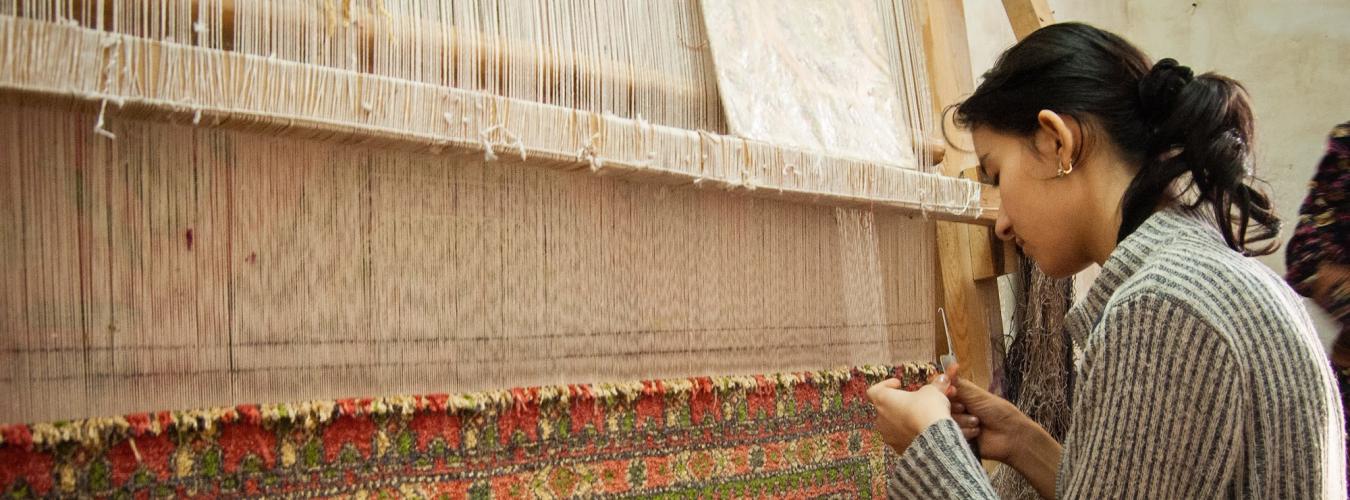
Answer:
[1285,122,1350,332]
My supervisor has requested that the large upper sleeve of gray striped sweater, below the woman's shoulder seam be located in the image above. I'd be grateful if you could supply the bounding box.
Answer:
[1056,293,1245,499]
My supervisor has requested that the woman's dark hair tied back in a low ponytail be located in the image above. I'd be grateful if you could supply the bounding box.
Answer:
[956,23,1280,255]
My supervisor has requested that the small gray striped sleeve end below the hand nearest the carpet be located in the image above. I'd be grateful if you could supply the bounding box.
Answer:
[887,419,996,499]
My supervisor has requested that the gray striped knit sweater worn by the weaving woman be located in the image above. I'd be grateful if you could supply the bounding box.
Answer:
[890,208,1346,499]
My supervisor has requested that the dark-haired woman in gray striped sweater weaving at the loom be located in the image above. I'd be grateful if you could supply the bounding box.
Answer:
[868,24,1346,499]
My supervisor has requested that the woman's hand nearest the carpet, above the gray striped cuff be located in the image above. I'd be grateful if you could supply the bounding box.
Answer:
[867,374,952,453]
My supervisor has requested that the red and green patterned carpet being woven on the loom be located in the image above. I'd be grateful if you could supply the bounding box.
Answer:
[0,365,934,499]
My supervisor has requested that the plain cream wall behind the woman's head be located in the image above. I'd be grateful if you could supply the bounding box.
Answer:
[965,0,1350,345]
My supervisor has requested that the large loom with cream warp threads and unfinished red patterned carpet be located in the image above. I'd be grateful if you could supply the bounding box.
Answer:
[0,0,1015,496]
